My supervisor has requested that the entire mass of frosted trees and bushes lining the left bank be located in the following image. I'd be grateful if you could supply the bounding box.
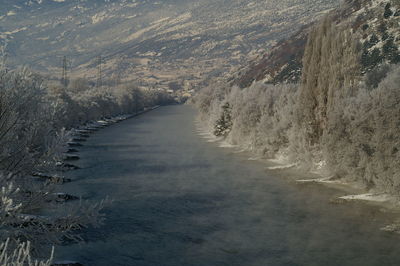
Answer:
[0,52,171,265]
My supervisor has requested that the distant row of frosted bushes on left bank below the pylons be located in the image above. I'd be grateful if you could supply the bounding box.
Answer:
[47,79,173,129]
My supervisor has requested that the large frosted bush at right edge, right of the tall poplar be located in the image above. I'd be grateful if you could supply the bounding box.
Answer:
[322,66,400,194]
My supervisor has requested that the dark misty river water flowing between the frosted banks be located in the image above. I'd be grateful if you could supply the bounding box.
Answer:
[56,106,400,266]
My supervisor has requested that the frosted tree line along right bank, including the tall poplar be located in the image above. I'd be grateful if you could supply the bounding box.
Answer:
[194,12,400,195]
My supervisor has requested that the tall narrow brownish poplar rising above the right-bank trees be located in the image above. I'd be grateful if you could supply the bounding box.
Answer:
[296,17,360,164]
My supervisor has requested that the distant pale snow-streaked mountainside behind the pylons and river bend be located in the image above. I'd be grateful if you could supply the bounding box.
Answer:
[0,0,338,90]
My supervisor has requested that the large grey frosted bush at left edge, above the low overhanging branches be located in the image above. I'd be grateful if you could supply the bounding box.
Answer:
[0,66,52,173]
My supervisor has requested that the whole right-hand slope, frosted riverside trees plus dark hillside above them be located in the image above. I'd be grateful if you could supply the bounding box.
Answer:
[195,0,400,198]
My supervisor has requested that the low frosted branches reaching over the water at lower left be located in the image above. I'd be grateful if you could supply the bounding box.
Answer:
[0,173,107,250]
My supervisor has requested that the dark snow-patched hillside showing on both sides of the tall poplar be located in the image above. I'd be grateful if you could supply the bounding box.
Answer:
[234,0,400,88]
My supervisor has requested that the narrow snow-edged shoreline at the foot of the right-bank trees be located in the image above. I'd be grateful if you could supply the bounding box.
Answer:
[196,117,400,233]
